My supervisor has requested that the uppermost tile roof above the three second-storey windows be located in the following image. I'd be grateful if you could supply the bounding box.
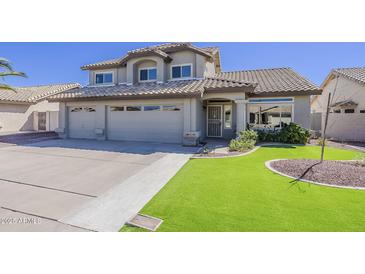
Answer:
[81,43,215,70]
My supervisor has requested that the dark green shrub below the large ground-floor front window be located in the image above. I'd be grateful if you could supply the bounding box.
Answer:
[257,123,310,144]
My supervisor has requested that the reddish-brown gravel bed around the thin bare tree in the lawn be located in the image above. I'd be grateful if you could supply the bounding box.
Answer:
[270,159,365,187]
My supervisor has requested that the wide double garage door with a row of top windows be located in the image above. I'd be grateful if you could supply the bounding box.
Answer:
[107,105,184,143]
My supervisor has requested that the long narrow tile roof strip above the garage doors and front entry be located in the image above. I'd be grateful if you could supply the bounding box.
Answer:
[50,77,254,101]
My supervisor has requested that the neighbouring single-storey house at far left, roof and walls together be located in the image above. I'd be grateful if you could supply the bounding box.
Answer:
[0,84,80,132]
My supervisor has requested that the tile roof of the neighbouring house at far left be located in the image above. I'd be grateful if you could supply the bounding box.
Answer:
[0,83,80,103]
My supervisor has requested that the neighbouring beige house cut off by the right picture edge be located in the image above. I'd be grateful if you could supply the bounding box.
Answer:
[311,67,365,142]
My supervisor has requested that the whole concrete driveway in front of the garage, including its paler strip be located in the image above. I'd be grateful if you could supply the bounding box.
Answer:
[0,139,196,231]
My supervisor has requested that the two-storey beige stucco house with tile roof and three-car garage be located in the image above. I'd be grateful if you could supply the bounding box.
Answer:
[50,43,320,145]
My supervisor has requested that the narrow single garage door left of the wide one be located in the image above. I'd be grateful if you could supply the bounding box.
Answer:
[68,106,95,139]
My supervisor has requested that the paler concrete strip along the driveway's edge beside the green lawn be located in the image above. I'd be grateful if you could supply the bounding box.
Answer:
[60,154,191,231]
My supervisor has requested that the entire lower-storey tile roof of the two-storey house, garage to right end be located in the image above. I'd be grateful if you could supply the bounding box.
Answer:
[50,68,320,101]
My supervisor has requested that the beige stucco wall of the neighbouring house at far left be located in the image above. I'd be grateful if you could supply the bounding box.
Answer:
[0,100,59,132]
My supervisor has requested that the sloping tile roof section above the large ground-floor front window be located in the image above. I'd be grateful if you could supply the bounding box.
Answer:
[217,68,320,94]
